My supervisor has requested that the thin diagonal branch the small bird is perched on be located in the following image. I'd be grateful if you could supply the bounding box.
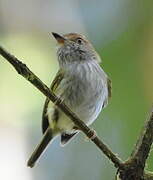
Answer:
[0,46,123,168]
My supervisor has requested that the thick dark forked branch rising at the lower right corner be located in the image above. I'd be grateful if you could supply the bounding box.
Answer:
[119,109,153,180]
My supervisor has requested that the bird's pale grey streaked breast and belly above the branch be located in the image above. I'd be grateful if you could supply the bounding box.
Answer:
[58,61,108,122]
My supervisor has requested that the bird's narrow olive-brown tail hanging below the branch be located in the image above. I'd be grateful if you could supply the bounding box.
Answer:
[27,127,55,168]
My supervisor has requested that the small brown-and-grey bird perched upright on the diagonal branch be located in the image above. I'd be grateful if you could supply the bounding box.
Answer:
[28,33,111,167]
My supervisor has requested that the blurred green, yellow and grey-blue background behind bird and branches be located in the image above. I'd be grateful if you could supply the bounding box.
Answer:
[0,0,153,180]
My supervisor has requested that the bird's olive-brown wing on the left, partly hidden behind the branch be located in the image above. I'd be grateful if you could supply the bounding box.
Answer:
[42,70,64,133]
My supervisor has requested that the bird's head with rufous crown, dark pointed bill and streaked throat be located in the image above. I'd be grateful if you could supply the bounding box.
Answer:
[52,33,100,65]
